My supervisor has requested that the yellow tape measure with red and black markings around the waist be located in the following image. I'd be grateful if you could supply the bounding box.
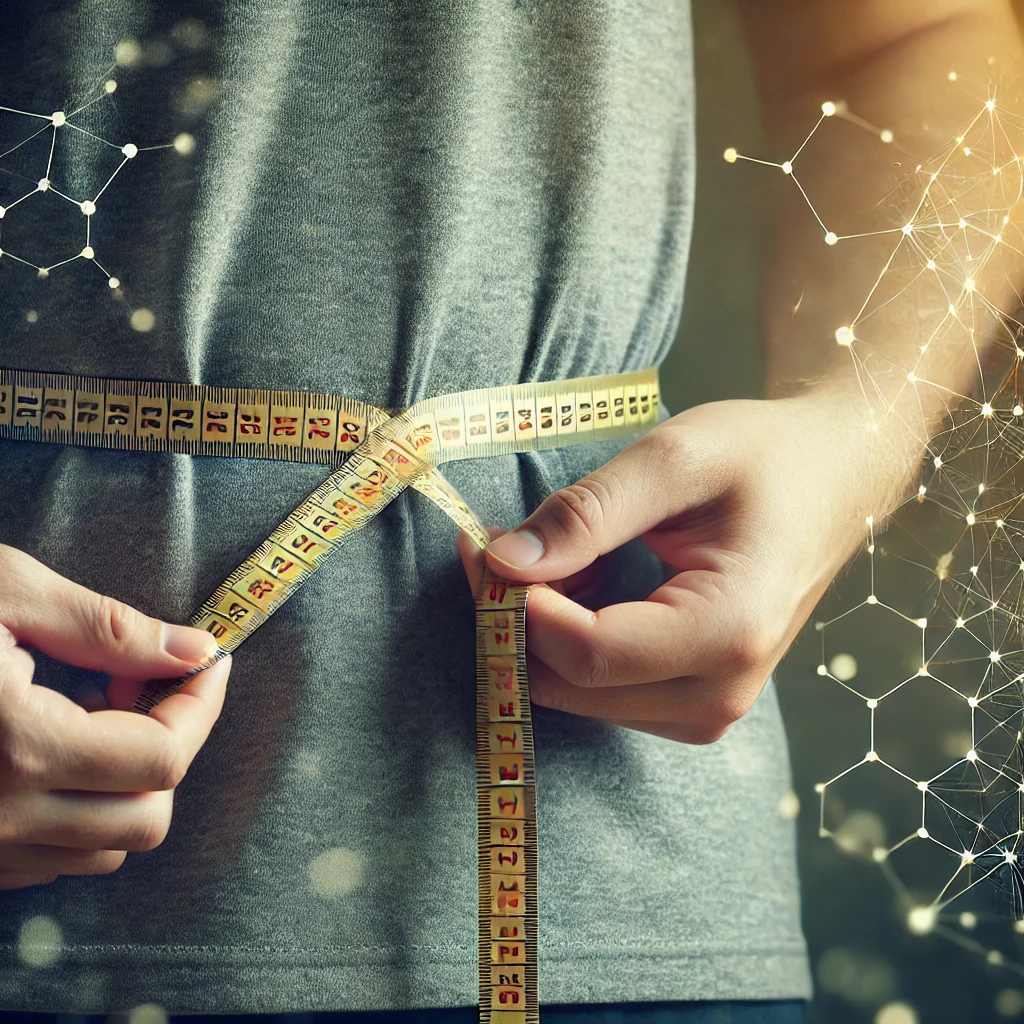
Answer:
[0,369,658,1024]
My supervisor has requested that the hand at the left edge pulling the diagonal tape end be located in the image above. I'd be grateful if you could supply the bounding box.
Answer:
[0,545,230,889]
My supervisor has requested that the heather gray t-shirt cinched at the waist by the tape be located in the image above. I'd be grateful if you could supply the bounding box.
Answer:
[0,0,810,1013]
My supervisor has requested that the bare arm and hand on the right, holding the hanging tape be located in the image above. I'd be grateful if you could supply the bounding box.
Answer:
[458,0,1024,743]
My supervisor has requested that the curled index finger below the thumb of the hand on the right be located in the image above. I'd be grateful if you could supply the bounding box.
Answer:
[526,570,745,687]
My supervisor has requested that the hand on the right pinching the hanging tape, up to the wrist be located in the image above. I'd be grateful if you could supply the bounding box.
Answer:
[458,396,888,743]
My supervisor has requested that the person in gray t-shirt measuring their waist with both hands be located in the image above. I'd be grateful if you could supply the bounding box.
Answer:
[0,0,1019,1024]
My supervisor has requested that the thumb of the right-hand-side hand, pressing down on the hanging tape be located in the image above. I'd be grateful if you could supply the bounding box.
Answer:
[486,424,722,583]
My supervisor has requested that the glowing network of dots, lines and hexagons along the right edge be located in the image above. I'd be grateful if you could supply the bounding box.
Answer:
[724,72,1024,975]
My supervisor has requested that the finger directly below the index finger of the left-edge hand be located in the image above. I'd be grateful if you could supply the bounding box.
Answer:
[0,791,174,851]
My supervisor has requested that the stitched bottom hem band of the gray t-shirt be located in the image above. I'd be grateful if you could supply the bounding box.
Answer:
[0,943,812,1014]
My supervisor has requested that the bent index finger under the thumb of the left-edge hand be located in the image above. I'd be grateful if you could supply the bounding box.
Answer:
[13,656,230,790]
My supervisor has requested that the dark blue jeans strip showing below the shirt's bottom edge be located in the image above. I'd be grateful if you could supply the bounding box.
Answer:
[0,999,807,1024]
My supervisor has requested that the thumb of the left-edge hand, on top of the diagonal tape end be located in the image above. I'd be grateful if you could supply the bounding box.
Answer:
[0,545,217,679]
